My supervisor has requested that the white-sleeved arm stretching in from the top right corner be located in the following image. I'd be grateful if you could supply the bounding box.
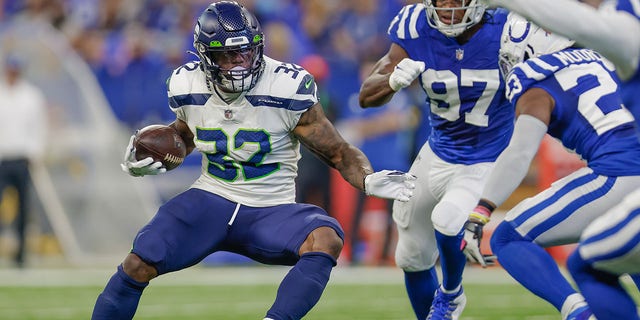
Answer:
[488,0,640,80]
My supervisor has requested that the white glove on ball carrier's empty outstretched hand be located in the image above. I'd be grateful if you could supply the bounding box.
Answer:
[364,170,416,202]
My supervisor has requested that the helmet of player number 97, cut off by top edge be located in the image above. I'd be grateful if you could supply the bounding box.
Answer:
[424,0,486,38]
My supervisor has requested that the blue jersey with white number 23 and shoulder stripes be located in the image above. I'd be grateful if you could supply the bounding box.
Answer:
[507,48,640,176]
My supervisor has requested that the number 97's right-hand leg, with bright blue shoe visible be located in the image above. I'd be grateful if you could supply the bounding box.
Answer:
[428,163,492,319]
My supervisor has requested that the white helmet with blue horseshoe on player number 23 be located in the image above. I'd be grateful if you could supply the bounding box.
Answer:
[498,13,574,79]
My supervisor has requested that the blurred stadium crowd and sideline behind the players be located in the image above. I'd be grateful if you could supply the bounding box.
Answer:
[0,0,600,318]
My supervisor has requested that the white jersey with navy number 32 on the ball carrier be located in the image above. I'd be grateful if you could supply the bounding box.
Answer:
[167,57,318,207]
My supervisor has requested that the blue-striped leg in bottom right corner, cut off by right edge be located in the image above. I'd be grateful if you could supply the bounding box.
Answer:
[567,191,640,320]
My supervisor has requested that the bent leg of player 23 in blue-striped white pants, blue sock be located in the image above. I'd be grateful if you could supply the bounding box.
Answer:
[491,168,638,319]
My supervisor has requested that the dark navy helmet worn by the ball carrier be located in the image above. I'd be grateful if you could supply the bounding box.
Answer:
[193,1,264,92]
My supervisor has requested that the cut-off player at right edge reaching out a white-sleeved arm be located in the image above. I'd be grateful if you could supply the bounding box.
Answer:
[482,0,640,320]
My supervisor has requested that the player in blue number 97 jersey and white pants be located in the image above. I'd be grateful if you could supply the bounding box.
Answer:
[360,0,514,319]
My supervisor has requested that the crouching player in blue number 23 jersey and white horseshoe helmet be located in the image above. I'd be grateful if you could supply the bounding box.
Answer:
[462,14,640,320]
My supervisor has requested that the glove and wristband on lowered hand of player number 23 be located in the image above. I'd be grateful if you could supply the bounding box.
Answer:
[461,207,496,268]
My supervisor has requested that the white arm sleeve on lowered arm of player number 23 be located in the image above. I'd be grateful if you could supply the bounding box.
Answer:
[482,114,547,206]
